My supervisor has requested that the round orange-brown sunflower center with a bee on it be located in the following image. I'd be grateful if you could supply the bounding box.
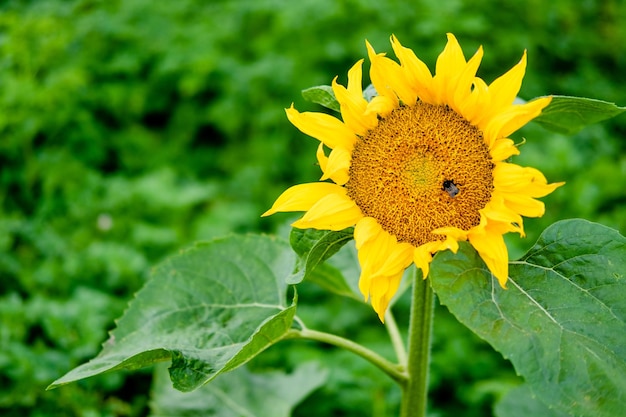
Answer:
[346,101,494,246]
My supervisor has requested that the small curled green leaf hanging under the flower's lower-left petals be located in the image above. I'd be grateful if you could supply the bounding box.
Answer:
[287,227,354,288]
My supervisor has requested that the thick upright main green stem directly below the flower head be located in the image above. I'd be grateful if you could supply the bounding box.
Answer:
[400,269,434,417]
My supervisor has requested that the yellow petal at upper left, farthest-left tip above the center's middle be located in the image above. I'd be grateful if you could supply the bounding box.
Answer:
[285,104,356,152]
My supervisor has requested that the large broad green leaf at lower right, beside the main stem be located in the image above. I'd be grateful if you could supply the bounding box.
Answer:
[430,220,626,417]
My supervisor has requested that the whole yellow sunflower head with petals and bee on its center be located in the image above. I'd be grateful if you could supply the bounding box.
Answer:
[263,34,563,320]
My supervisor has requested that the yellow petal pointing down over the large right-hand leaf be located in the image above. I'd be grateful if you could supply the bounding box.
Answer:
[469,229,509,288]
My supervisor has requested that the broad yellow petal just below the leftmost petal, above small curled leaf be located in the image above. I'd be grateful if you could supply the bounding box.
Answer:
[292,192,363,230]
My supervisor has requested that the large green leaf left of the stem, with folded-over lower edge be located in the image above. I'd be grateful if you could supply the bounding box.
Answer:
[49,235,295,391]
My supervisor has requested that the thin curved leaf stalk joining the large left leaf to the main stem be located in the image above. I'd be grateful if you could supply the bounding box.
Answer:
[286,327,407,385]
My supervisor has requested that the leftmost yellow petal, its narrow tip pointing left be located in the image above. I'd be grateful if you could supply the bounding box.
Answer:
[262,182,346,217]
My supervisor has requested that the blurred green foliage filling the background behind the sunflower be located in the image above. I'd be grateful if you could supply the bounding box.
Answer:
[0,0,626,416]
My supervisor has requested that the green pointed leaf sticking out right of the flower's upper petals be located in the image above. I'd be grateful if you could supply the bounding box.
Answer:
[533,96,626,135]
